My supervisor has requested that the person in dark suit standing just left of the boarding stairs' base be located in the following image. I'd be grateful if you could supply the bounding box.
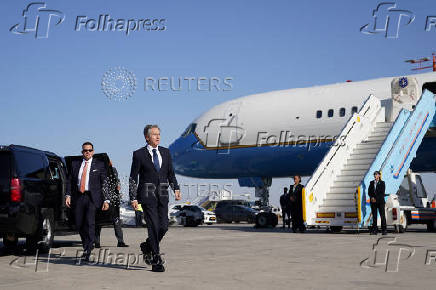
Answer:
[289,175,306,233]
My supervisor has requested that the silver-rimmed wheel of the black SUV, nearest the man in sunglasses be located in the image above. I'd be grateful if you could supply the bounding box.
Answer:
[26,209,54,253]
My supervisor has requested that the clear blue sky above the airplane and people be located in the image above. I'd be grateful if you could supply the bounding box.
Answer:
[0,0,436,204]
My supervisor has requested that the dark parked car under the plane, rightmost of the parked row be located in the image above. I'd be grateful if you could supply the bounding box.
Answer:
[215,204,258,223]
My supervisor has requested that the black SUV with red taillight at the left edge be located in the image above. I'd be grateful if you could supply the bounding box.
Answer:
[0,145,112,251]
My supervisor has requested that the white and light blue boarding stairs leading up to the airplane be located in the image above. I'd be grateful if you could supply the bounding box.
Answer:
[303,79,435,227]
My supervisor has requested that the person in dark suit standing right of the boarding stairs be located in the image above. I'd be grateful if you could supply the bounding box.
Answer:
[368,171,386,235]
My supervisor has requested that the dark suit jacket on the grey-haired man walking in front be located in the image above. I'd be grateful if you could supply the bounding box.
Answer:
[129,146,179,203]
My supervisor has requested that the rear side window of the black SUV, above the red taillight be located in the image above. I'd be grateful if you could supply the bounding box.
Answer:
[15,151,45,179]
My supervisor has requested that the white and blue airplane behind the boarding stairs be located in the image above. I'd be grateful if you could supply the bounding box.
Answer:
[170,72,436,201]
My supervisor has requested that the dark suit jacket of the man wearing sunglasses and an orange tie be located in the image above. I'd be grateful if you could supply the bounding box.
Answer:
[67,158,109,208]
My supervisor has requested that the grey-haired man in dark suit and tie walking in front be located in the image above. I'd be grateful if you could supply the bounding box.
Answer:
[129,125,181,272]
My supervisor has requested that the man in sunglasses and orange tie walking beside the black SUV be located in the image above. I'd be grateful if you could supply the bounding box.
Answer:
[65,142,109,261]
